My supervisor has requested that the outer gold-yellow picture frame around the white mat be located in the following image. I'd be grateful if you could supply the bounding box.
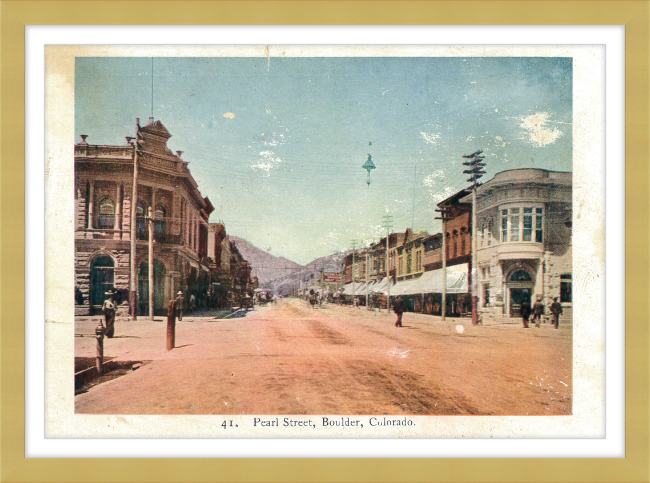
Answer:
[0,0,650,482]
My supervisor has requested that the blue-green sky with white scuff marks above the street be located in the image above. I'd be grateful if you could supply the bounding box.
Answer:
[75,57,573,264]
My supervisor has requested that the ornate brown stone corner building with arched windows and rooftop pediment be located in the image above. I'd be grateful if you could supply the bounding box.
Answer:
[74,118,214,316]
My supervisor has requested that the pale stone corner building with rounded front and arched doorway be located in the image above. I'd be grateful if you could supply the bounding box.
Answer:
[461,169,572,317]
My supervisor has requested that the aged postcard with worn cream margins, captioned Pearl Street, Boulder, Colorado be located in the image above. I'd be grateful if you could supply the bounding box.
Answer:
[46,45,604,438]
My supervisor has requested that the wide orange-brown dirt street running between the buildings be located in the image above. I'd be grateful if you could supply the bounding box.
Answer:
[75,299,572,416]
